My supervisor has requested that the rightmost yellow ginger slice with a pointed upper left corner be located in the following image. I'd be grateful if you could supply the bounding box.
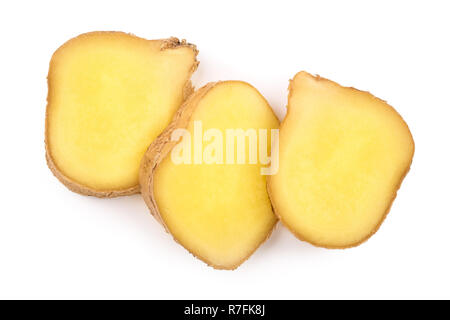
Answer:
[268,72,414,248]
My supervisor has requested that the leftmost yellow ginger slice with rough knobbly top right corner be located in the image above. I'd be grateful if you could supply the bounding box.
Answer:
[45,32,198,197]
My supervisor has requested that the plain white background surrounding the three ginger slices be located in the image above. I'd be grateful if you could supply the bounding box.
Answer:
[0,0,450,299]
